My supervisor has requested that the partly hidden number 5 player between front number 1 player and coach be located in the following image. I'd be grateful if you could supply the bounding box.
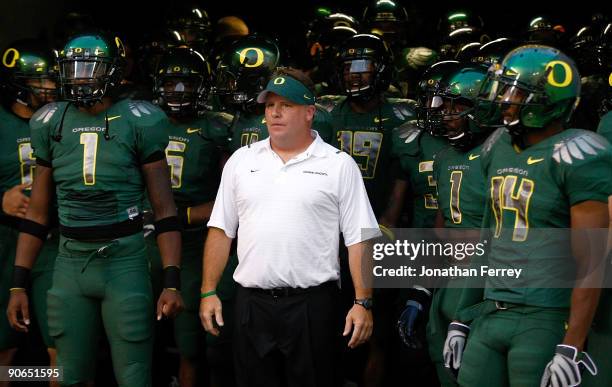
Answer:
[147,48,232,387]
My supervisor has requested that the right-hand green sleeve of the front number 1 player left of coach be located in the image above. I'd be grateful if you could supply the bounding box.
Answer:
[129,101,170,164]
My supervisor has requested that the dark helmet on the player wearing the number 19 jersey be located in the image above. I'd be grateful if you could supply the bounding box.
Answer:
[337,34,392,101]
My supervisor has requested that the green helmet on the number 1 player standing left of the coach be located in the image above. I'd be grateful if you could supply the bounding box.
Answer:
[58,33,125,106]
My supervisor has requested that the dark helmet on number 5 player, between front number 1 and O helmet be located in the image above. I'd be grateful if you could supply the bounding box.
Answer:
[154,47,212,115]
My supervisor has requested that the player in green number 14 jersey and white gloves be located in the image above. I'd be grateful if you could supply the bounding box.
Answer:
[444,45,612,387]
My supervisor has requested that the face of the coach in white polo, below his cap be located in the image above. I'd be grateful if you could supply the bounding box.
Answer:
[265,93,315,139]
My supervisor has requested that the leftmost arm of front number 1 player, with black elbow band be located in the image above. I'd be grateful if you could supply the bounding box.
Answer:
[7,165,54,332]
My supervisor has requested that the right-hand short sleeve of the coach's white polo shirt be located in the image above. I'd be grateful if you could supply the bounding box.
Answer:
[338,154,382,247]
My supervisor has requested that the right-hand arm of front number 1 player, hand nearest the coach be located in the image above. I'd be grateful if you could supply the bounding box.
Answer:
[142,157,183,320]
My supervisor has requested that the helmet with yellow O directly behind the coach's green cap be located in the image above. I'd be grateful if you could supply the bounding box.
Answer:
[214,35,280,108]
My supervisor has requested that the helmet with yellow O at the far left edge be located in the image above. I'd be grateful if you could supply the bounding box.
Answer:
[2,40,58,109]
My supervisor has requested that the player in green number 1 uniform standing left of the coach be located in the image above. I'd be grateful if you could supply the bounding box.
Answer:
[7,33,183,387]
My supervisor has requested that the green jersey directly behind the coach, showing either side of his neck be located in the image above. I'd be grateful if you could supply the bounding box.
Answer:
[230,104,332,153]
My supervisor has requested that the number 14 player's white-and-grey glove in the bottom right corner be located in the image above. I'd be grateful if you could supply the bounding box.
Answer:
[540,344,597,387]
